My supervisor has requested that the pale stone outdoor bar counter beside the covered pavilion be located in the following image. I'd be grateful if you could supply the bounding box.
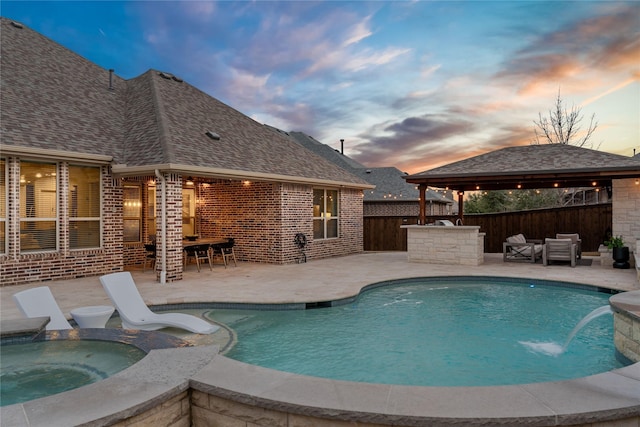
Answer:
[401,225,485,265]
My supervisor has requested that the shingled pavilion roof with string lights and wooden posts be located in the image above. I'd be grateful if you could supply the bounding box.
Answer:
[404,144,640,225]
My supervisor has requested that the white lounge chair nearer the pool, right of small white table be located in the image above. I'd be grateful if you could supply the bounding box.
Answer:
[100,271,219,334]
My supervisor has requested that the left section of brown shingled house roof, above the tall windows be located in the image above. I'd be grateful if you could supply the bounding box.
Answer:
[0,18,125,159]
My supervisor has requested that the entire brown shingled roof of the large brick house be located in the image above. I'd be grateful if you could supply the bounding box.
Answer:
[0,18,371,189]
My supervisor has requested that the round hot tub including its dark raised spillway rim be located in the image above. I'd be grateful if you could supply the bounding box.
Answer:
[0,329,189,406]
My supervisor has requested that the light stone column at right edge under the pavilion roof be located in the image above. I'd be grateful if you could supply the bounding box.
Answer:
[612,179,640,252]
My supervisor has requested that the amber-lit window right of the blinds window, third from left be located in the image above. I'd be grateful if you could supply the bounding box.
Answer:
[68,166,101,249]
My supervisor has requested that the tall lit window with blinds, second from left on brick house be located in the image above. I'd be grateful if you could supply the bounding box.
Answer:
[20,161,58,252]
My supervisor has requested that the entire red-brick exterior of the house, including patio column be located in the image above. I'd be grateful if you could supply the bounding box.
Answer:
[0,168,363,286]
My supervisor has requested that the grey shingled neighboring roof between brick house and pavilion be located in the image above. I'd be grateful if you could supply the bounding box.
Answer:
[284,128,452,203]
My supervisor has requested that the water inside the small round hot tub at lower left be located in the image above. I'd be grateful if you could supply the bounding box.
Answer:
[0,340,146,406]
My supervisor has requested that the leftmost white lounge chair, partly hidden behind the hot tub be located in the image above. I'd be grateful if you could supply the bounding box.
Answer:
[13,286,73,331]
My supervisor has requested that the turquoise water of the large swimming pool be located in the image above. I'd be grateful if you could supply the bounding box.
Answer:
[209,280,623,386]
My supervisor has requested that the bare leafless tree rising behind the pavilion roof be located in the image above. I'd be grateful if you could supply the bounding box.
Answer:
[533,90,598,148]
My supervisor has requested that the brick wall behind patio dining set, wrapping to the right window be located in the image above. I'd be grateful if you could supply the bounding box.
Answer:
[198,181,363,264]
